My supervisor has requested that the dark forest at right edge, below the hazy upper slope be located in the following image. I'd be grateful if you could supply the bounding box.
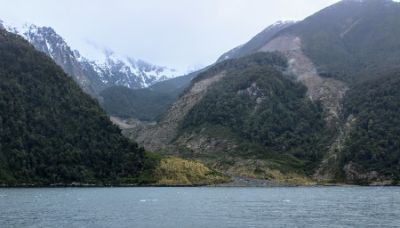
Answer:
[343,70,400,179]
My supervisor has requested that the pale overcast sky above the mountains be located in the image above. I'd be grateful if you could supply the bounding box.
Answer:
[0,0,339,71]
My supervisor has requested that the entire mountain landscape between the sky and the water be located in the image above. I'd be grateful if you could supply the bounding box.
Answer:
[0,0,400,186]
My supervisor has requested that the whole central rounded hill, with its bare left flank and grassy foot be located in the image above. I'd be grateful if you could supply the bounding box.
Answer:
[131,53,329,178]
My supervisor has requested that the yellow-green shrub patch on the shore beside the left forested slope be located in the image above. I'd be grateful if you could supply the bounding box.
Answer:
[139,152,230,186]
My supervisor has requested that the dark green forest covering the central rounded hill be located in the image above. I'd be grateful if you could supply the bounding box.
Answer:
[181,53,326,174]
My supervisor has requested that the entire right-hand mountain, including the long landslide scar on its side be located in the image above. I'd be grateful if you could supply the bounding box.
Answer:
[206,0,400,183]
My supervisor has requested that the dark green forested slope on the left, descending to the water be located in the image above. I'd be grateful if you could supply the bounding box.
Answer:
[0,30,143,185]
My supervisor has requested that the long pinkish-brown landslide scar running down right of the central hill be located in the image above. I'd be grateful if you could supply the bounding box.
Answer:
[260,35,354,180]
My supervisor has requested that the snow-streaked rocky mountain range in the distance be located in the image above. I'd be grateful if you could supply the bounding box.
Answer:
[2,23,180,97]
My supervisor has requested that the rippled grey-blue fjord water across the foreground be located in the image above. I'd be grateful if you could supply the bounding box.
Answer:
[0,187,400,228]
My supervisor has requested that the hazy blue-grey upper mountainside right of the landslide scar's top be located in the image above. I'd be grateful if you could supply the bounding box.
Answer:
[290,0,400,83]
